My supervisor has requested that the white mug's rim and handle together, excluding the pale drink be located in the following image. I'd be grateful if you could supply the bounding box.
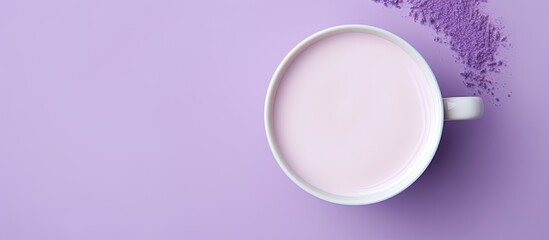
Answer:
[265,25,483,205]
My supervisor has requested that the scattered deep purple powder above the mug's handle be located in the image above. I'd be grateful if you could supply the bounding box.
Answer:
[373,0,510,102]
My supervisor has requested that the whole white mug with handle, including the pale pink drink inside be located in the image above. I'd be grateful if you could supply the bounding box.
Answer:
[264,25,483,205]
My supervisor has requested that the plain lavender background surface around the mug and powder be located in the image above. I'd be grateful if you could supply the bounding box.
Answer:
[0,0,549,240]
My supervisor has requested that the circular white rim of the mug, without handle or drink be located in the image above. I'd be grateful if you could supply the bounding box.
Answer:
[264,24,444,205]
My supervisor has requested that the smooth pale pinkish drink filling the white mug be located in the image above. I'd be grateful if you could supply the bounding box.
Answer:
[273,31,439,196]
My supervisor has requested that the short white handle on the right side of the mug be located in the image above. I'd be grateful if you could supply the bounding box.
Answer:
[442,97,484,121]
